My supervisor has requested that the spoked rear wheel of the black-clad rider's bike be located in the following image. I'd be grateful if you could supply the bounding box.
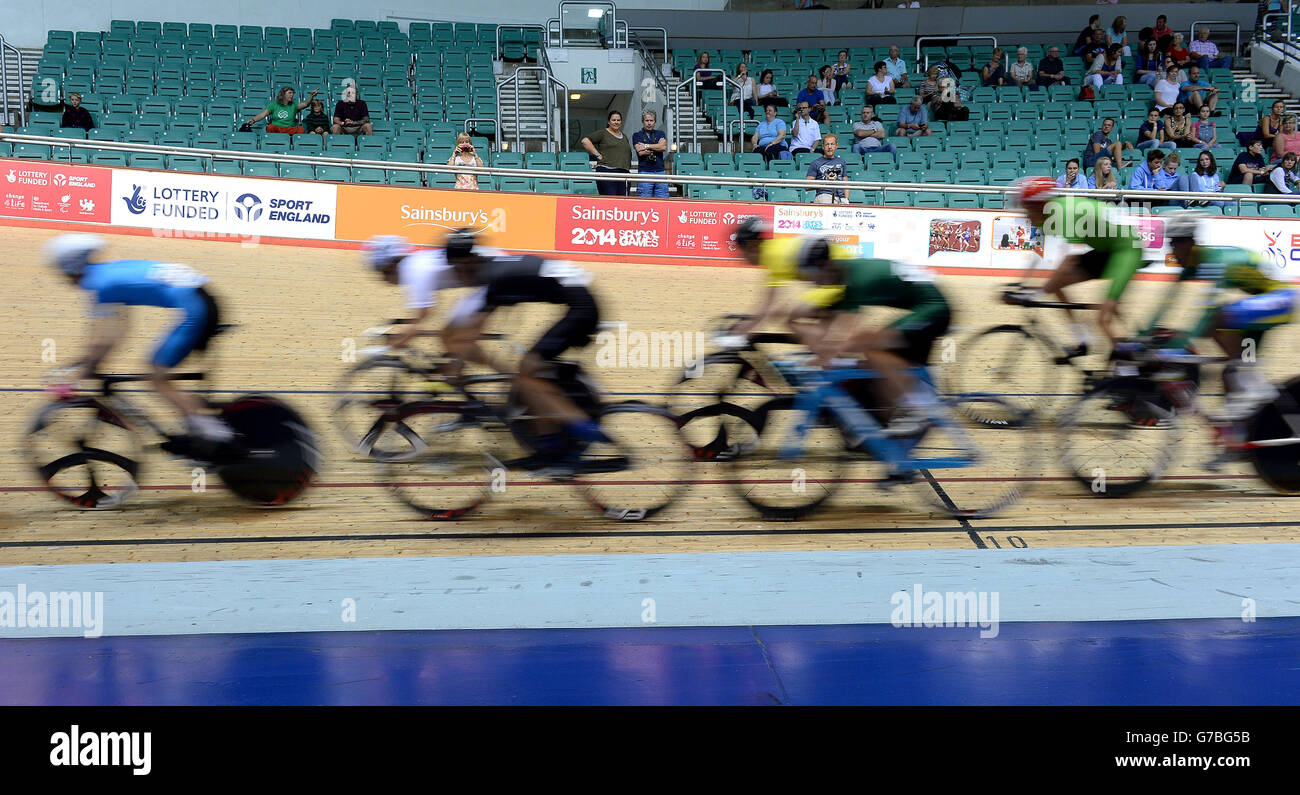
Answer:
[573,400,694,521]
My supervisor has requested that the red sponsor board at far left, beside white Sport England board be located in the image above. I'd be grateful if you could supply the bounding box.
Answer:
[0,160,112,223]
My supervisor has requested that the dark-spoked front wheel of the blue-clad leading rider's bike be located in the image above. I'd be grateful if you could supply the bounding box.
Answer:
[27,398,140,511]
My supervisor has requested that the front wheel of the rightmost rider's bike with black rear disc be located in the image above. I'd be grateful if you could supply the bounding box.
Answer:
[1057,379,1180,496]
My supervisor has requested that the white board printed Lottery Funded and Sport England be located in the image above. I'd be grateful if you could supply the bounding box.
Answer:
[112,169,338,240]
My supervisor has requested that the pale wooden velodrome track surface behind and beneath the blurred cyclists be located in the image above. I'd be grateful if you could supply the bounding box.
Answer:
[0,227,1300,565]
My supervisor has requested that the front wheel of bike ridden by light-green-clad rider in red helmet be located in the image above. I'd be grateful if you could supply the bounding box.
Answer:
[944,326,1063,423]
